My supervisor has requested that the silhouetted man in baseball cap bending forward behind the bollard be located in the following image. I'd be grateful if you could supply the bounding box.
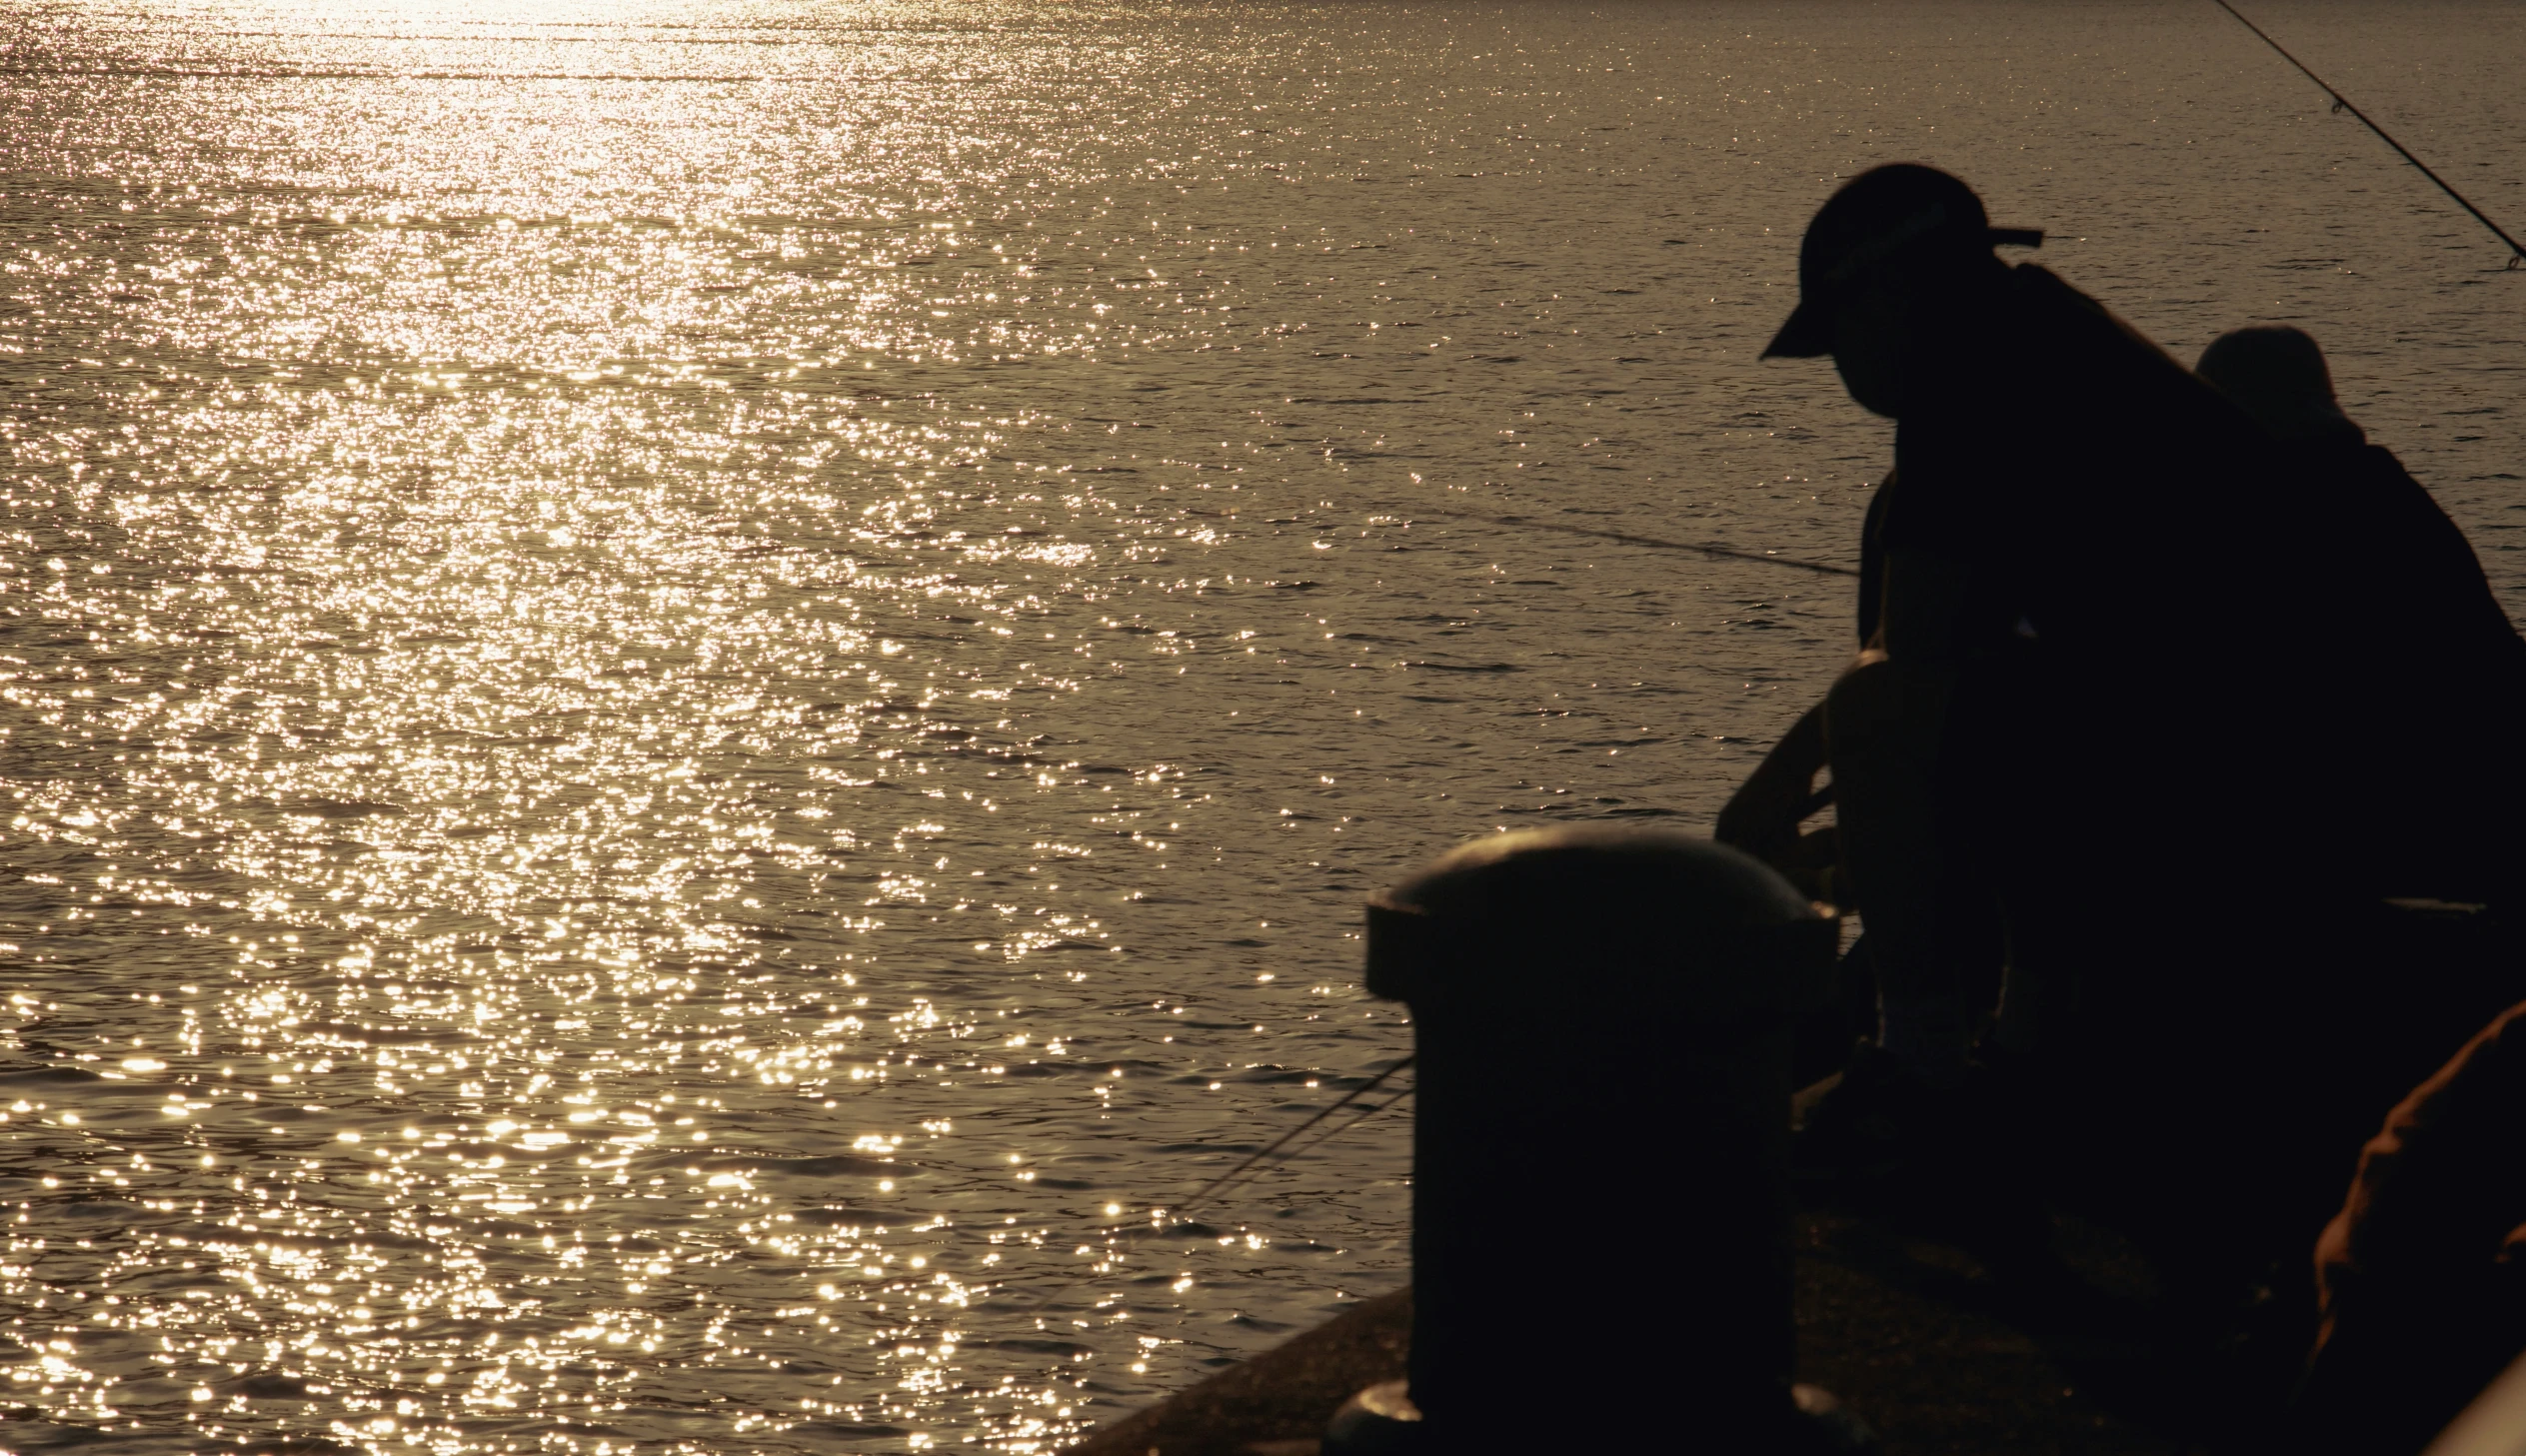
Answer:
[1730,164,2324,1281]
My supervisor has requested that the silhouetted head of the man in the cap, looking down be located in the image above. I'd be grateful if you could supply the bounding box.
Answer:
[1763,162,2043,417]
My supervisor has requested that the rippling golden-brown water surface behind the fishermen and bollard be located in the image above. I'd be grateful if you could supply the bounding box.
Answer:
[0,0,2526,1453]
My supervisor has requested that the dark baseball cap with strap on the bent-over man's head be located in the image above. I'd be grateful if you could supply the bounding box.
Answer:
[1763,162,2043,359]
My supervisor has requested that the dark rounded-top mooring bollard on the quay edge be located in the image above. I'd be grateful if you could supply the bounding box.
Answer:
[1326,827,1846,1456]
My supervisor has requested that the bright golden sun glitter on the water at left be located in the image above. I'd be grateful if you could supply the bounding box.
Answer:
[0,8,1474,1451]
